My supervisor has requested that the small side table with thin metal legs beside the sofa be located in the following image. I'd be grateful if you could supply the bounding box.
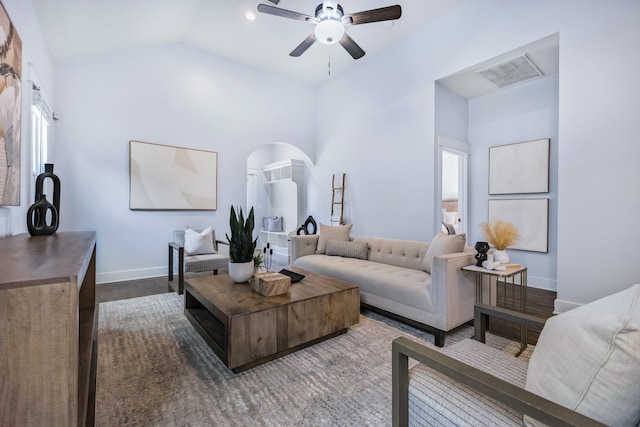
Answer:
[462,265,527,356]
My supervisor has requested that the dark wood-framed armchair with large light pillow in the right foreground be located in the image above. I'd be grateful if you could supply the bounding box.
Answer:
[392,285,640,427]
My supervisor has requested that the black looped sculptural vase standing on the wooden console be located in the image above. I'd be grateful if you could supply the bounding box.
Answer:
[27,163,60,236]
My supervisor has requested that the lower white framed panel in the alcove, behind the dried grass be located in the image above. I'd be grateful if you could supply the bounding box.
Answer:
[489,199,549,252]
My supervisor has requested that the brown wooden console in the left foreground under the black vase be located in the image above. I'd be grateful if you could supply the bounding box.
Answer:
[0,232,97,426]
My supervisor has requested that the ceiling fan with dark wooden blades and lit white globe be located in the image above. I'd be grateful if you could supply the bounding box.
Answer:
[258,0,402,59]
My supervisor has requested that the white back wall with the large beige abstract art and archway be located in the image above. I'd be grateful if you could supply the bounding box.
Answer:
[54,44,315,282]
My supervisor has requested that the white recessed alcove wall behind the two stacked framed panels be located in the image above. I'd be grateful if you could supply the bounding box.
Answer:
[467,75,558,291]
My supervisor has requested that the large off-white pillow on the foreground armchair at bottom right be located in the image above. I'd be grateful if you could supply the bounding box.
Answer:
[524,284,640,426]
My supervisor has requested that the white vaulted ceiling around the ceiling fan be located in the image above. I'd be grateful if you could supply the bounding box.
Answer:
[33,0,465,85]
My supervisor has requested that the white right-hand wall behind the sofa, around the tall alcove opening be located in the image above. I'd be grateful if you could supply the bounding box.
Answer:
[316,0,640,309]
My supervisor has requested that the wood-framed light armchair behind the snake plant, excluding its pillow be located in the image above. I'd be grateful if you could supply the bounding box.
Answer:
[168,230,230,294]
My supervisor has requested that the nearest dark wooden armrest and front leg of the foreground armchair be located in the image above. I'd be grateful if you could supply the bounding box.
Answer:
[391,337,604,426]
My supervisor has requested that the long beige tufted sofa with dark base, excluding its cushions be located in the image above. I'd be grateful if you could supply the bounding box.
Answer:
[290,235,476,347]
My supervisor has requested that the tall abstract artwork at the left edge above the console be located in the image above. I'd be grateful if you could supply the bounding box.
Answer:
[0,3,22,206]
